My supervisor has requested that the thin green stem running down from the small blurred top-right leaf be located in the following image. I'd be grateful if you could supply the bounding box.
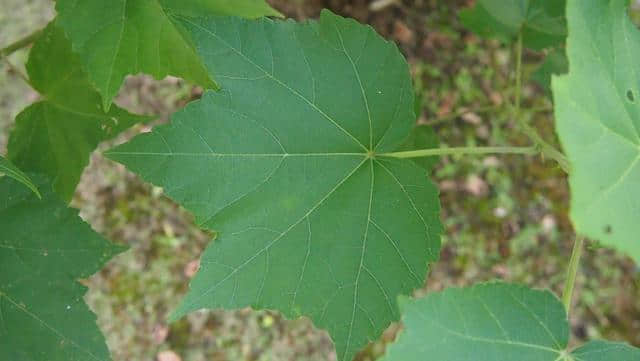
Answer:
[513,32,570,173]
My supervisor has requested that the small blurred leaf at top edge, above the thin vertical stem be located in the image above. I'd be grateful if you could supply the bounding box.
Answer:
[460,0,567,50]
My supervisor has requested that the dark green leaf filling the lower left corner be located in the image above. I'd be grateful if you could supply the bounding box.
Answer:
[0,177,122,361]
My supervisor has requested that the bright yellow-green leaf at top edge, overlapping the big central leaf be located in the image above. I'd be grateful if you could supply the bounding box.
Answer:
[56,0,279,109]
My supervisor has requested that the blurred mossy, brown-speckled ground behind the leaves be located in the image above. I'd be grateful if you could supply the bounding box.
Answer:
[0,0,640,361]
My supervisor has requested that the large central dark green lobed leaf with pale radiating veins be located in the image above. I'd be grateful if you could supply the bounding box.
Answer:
[107,11,441,360]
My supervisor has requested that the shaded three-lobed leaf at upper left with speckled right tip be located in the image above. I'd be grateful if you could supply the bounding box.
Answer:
[8,23,147,201]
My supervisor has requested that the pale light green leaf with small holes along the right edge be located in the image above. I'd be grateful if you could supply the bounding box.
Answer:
[553,0,640,261]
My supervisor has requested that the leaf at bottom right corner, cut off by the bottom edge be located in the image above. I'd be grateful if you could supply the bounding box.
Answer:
[383,283,640,361]
